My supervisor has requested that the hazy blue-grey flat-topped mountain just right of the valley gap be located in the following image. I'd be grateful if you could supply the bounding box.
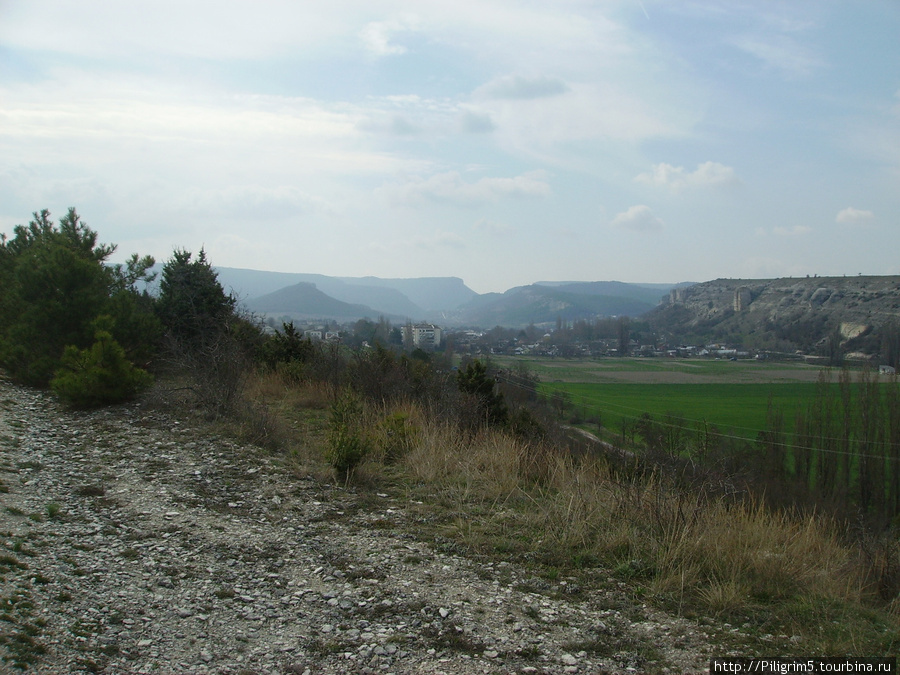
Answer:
[449,282,672,328]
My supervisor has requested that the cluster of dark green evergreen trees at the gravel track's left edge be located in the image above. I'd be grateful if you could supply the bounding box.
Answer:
[0,208,258,407]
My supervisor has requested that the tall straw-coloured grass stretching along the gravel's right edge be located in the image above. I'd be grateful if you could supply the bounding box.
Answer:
[403,410,866,613]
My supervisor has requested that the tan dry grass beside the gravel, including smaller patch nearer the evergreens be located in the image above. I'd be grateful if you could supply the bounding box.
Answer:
[239,375,900,655]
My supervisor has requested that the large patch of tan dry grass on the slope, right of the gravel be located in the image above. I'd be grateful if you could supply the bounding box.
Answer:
[392,412,900,653]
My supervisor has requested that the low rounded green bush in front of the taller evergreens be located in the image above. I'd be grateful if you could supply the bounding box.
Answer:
[50,317,153,408]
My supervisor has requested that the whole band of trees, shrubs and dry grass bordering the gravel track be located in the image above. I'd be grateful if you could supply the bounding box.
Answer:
[0,209,900,656]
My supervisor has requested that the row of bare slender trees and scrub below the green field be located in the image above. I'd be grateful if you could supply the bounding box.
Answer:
[596,368,900,529]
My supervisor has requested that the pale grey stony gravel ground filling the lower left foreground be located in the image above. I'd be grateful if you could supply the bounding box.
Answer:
[0,380,721,675]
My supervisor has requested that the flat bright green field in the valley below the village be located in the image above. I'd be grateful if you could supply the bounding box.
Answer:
[494,357,838,438]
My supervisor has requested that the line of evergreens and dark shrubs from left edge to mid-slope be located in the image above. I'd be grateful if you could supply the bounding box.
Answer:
[0,208,553,448]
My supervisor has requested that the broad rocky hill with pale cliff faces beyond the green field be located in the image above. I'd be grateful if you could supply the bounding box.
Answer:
[645,276,900,355]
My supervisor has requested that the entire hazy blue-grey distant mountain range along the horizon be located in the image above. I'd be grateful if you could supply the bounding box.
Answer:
[216,267,690,328]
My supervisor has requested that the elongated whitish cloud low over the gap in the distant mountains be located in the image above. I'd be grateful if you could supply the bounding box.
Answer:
[386,171,551,206]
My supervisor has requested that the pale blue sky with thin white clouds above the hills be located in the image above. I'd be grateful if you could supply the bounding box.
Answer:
[0,0,900,293]
